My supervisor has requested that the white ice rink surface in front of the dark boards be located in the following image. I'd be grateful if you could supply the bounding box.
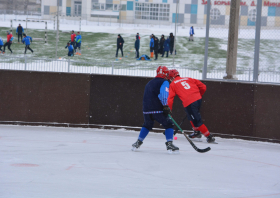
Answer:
[0,125,280,198]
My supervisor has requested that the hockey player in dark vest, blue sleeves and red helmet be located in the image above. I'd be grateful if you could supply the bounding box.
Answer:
[132,66,179,153]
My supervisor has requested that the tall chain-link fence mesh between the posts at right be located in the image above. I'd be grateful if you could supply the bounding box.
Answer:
[205,0,280,82]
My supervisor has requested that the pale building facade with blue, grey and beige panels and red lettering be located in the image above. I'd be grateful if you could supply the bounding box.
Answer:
[41,0,280,27]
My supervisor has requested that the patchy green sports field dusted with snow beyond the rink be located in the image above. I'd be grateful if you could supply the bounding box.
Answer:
[0,16,280,71]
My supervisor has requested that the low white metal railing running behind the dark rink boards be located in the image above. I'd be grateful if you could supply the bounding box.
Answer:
[0,55,280,83]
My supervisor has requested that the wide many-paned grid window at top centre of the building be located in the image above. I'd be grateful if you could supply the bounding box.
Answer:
[135,3,170,21]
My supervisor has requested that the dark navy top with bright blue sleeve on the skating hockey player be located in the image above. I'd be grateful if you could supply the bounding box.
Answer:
[143,77,169,114]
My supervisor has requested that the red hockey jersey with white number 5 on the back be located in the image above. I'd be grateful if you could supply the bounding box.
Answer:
[167,76,206,110]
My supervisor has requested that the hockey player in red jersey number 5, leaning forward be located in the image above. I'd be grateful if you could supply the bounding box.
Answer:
[167,69,215,143]
